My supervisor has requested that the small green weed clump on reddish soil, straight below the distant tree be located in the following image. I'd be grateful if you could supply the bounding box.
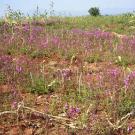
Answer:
[85,54,103,63]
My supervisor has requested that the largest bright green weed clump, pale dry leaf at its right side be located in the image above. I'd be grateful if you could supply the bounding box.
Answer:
[28,75,59,94]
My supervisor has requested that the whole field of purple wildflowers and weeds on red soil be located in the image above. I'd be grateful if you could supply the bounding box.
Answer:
[0,9,135,135]
